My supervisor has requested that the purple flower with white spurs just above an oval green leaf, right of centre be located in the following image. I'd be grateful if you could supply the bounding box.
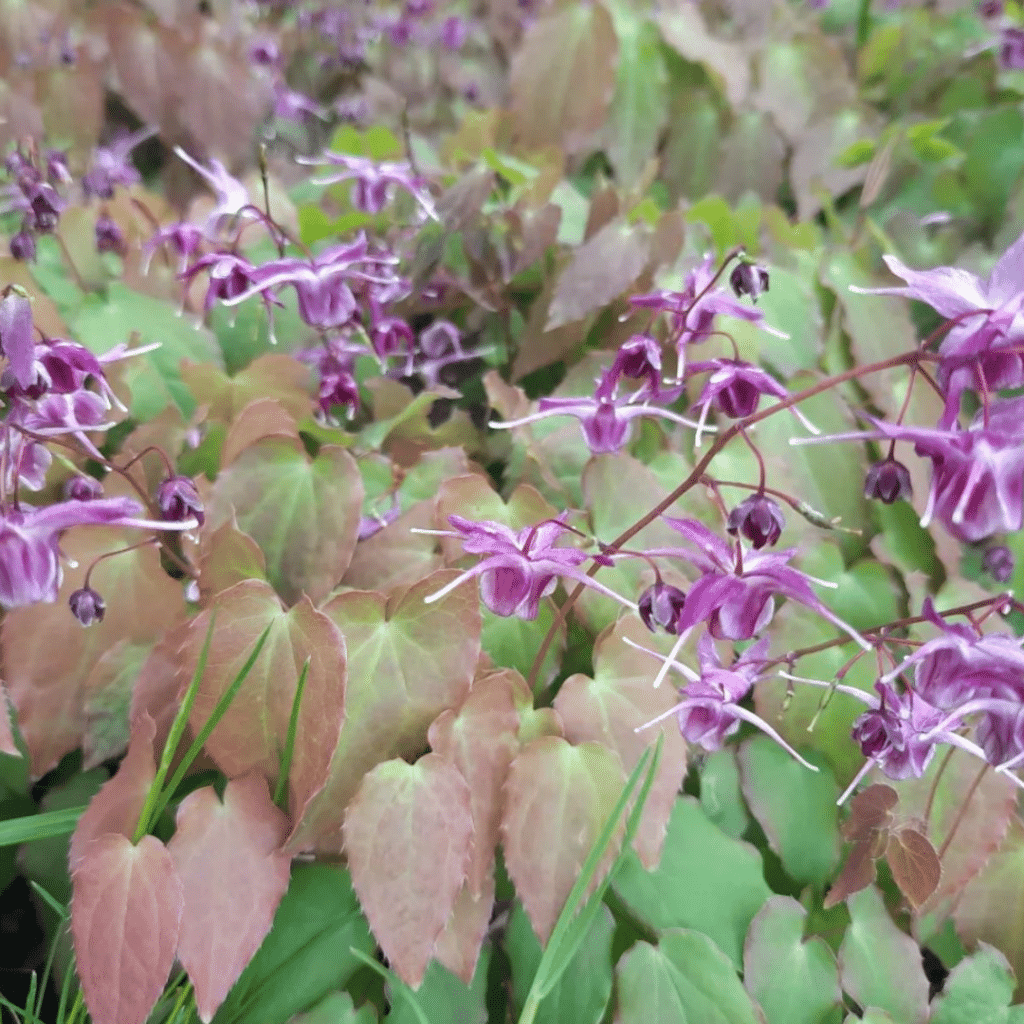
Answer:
[626,633,818,771]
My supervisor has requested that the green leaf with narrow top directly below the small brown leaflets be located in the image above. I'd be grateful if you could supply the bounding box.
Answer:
[839,886,928,1024]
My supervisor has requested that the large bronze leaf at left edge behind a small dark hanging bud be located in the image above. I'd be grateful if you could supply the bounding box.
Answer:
[0,526,184,776]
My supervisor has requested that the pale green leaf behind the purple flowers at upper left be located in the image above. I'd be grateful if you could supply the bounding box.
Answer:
[68,282,222,420]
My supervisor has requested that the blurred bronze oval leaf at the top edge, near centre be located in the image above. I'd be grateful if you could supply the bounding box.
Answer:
[510,3,618,154]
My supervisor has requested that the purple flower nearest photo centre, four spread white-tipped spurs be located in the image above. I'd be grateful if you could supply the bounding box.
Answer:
[416,515,636,620]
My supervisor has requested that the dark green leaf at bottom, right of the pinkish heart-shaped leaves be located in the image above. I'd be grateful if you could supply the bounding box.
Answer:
[213,864,375,1024]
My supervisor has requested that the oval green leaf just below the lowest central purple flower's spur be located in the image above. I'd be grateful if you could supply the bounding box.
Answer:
[738,736,840,890]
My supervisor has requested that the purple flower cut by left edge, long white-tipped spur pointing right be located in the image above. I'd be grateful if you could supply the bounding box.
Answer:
[0,498,196,608]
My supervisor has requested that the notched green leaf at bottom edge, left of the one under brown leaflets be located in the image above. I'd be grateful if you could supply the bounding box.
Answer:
[743,896,843,1024]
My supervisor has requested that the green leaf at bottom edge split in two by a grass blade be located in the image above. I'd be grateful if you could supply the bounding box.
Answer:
[505,900,614,1024]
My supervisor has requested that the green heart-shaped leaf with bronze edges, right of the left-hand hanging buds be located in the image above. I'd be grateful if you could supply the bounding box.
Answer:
[208,438,362,604]
